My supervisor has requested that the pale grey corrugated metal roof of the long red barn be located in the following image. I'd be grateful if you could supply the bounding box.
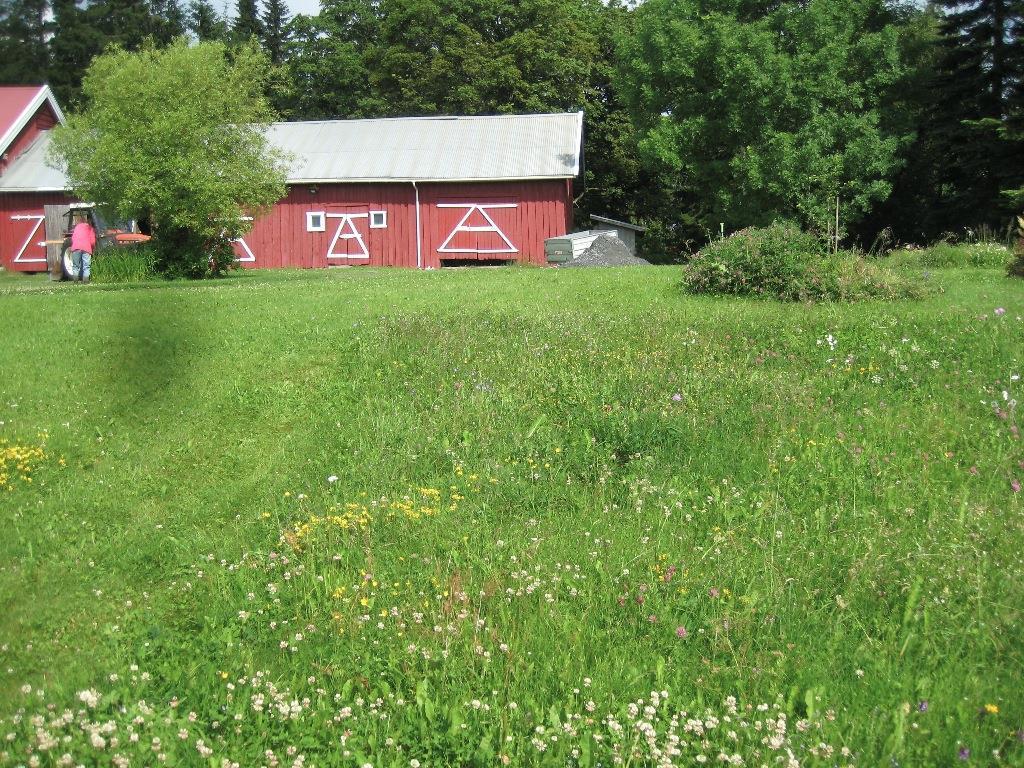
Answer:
[0,113,583,191]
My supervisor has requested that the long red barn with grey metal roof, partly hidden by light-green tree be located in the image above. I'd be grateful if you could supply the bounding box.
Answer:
[0,90,583,269]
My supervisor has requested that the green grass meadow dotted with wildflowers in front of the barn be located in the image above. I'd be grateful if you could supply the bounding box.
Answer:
[0,267,1024,766]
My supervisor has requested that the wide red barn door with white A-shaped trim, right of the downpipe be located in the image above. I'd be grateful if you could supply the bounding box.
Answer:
[436,198,519,259]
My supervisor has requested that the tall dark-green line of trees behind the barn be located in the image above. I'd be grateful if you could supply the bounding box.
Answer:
[0,0,1024,257]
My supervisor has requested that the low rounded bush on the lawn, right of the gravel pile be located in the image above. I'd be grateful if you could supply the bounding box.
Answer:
[684,222,922,301]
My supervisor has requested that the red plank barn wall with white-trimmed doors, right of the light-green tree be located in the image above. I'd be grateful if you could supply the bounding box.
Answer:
[236,180,571,268]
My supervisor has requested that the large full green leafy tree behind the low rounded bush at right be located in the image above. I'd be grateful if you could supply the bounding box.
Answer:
[617,0,911,237]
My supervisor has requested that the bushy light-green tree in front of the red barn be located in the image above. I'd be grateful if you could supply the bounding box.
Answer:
[52,39,286,275]
